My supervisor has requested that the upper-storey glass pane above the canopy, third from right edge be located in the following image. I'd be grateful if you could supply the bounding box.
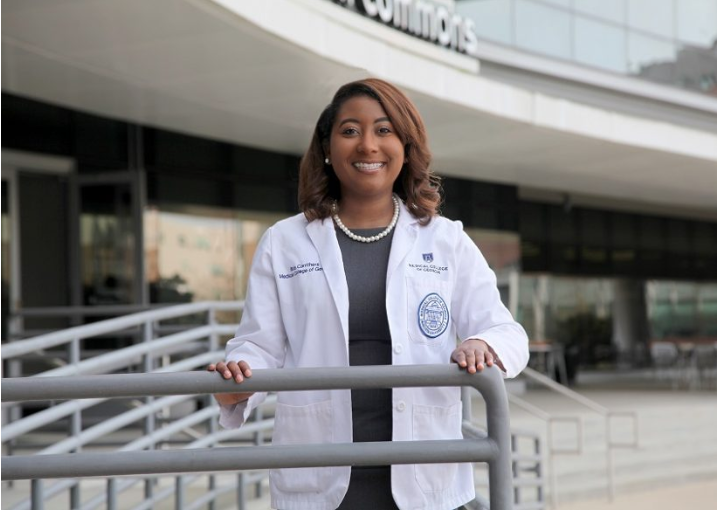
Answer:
[574,16,627,73]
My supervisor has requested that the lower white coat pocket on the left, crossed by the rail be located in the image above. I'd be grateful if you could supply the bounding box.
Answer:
[270,400,333,493]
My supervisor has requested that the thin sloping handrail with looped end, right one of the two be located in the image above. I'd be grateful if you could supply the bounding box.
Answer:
[522,367,639,501]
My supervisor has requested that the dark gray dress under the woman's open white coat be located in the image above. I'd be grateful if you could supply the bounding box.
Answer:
[337,228,397,510]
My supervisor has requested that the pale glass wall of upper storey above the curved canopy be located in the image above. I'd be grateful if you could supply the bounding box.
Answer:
[456,0,717,97]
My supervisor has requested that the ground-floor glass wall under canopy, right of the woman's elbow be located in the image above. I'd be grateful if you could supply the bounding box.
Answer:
[516,274,717,364]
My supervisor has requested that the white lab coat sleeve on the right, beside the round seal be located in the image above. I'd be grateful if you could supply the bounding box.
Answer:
[452,222,529,377]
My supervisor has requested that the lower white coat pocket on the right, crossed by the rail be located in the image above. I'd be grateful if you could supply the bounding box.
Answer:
[412,402,462,492]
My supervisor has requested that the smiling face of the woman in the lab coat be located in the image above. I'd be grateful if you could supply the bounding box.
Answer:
[327,96,404,198]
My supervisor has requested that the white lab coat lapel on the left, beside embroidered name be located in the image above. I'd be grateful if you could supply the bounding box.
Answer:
[306,218,349,344]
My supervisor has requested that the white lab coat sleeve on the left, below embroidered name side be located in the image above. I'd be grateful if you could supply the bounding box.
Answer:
[220,228,287,428]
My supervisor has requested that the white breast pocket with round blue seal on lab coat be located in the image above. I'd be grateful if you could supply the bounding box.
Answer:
[406,276,452,349]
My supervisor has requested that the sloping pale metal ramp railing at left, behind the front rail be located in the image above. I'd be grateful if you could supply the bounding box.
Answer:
[2,302,248,510]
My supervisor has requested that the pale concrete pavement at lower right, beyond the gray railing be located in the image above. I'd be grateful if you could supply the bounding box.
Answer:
[473,372,717,510]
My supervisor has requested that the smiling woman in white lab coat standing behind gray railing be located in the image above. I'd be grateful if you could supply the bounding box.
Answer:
[209,79,528,510]
